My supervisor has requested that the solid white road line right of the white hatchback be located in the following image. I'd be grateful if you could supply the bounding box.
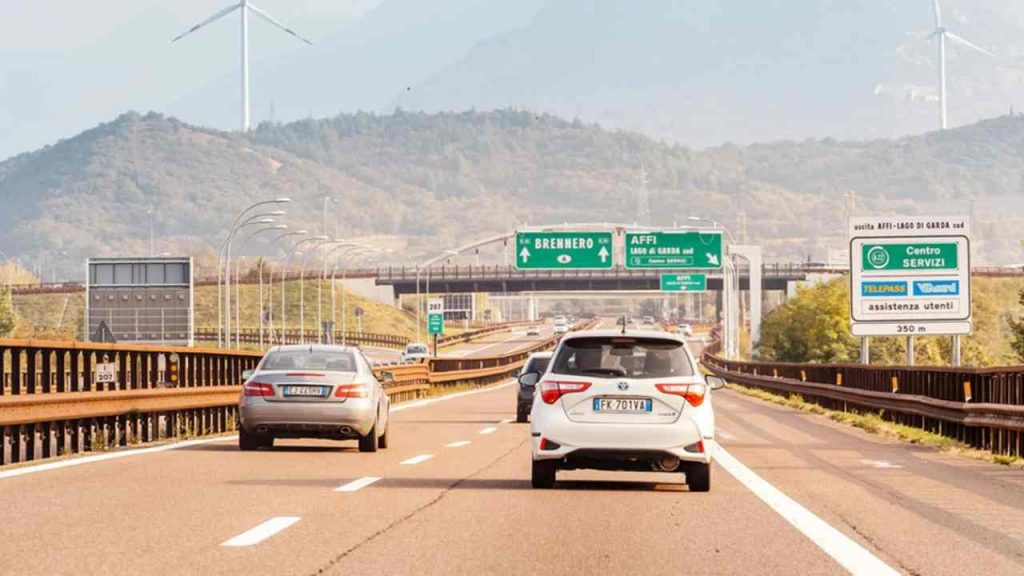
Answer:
[712,443,899,576]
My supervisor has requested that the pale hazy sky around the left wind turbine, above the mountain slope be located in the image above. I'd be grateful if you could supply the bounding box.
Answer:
[0,0,379,160]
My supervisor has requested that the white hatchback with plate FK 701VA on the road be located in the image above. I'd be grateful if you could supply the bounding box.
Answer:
[519,330,725,492]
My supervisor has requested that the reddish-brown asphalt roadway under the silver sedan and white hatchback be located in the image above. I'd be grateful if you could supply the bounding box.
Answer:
[0,364,1024,575]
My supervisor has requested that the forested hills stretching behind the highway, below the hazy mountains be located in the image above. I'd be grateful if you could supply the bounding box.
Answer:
[0,111,1024,263]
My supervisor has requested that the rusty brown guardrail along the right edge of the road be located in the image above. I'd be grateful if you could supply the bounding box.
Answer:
[703,355,1024,456]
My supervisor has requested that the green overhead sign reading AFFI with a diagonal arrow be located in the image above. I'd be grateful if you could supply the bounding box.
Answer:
[626,232,722,269]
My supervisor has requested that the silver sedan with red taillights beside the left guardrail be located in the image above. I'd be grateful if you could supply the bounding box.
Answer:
[239,344,391,452]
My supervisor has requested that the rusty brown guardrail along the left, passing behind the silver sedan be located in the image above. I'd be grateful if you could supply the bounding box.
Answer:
[0,317,585,465]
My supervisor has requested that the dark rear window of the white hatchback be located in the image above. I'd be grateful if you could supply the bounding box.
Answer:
[551,336,693,378]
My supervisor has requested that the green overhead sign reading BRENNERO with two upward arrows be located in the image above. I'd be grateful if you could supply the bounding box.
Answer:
[515,232,612,270]
